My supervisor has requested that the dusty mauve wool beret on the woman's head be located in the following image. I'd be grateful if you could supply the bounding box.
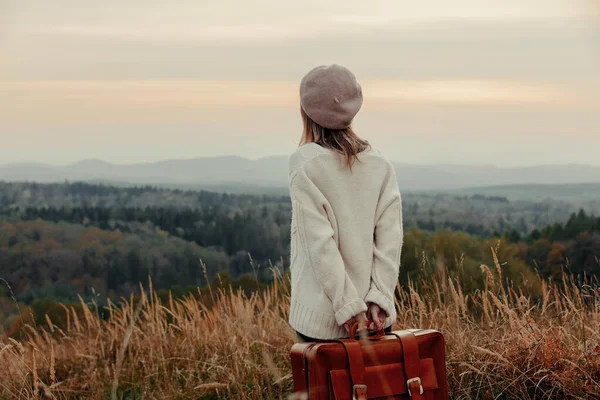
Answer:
[300,64,362,129]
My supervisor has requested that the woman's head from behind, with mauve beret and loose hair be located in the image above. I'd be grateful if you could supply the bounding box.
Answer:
[300,64,370,168]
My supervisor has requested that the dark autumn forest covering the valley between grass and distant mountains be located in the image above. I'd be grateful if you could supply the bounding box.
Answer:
[0,183,600,334]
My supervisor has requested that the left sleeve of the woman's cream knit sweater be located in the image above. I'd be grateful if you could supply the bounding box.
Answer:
[290,171,367,326]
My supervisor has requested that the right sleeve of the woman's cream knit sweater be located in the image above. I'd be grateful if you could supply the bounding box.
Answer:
[365,169,403,317]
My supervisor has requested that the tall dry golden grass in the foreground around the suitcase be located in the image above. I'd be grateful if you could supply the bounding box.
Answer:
[0,253,600,400]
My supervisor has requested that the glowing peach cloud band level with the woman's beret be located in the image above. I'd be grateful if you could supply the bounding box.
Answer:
[0,80,600,127]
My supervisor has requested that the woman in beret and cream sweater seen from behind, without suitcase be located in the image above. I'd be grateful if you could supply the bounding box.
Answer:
[289,64,402,341]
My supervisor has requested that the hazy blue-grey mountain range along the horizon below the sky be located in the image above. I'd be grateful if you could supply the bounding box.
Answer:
[0,156,600,191]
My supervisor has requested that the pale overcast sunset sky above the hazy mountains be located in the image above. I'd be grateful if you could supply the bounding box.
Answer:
[0,0,600,166]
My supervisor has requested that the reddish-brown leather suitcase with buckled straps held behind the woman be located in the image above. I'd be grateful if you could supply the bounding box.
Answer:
[290,327,448,400]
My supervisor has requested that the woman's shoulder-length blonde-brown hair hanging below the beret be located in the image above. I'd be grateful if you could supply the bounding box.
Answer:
[299,107,371,170]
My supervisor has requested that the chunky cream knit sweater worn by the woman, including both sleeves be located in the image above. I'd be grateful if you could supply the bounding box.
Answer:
[289,143,403,339]
